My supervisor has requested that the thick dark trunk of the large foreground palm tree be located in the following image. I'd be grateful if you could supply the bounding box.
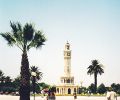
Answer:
[19,51,30,100]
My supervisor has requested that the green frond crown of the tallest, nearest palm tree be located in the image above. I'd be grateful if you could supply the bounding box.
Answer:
[0,22,46,51]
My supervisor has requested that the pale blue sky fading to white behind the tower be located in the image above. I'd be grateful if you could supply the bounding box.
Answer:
[0,0,120,86]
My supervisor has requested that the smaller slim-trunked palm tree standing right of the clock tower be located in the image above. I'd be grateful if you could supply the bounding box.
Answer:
[87,60,104,93]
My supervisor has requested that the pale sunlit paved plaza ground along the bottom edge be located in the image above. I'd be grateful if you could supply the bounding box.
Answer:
[0,95,120,100]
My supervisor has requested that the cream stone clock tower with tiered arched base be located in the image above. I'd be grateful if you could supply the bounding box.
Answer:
[56,42,79,95]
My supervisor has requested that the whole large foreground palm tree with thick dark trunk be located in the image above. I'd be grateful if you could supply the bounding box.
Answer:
[1,22,46,100]
